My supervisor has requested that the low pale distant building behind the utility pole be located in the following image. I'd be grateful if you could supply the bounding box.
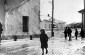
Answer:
[40,19,65,31]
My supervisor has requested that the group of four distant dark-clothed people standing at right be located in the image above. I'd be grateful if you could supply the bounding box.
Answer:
[64,27,84,41]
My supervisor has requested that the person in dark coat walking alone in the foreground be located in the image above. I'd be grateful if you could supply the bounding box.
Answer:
[40,29,48,55]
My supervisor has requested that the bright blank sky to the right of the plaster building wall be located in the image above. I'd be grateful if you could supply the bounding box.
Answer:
[40,0,84,24]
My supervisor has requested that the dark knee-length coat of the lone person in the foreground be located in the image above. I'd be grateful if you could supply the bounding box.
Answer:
[40,34,48,48]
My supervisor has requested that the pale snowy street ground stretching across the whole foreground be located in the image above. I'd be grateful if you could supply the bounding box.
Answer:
[0,37,85,55]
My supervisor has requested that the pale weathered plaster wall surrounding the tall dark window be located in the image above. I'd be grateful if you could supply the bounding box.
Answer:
[5,0,40,35]
